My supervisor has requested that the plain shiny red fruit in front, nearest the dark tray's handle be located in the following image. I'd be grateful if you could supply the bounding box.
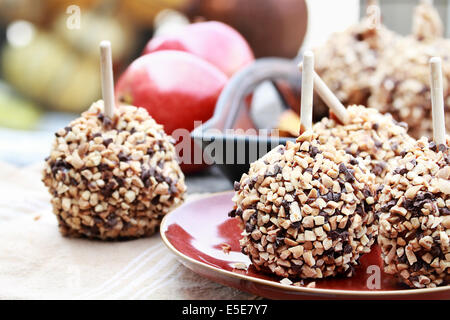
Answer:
[116,50,228,172]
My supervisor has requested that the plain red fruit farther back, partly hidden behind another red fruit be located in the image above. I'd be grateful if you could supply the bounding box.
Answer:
[144,21,254,77]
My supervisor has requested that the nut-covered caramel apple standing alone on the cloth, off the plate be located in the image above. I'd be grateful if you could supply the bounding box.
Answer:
[43,101,186,240]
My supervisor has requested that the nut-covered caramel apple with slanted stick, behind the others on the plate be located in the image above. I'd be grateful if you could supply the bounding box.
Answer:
[313,105,415,184]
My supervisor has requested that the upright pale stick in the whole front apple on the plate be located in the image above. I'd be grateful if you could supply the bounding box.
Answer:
[300,51,314,132]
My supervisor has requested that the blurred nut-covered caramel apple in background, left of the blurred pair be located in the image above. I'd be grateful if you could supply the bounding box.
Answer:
[314,6,398,116]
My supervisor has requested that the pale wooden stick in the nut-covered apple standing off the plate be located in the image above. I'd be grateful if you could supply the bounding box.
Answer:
[100,40,114,119]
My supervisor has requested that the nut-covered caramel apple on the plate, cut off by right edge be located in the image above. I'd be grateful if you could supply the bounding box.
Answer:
[376,138,450,288]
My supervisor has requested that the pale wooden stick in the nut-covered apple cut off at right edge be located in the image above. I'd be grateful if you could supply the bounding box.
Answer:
[430,57,446,145]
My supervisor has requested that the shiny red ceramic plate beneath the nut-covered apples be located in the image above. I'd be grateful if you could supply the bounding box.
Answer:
[161,192,450,299]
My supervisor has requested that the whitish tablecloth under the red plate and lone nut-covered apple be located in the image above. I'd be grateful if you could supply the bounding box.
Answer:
[0,163,255,299]
